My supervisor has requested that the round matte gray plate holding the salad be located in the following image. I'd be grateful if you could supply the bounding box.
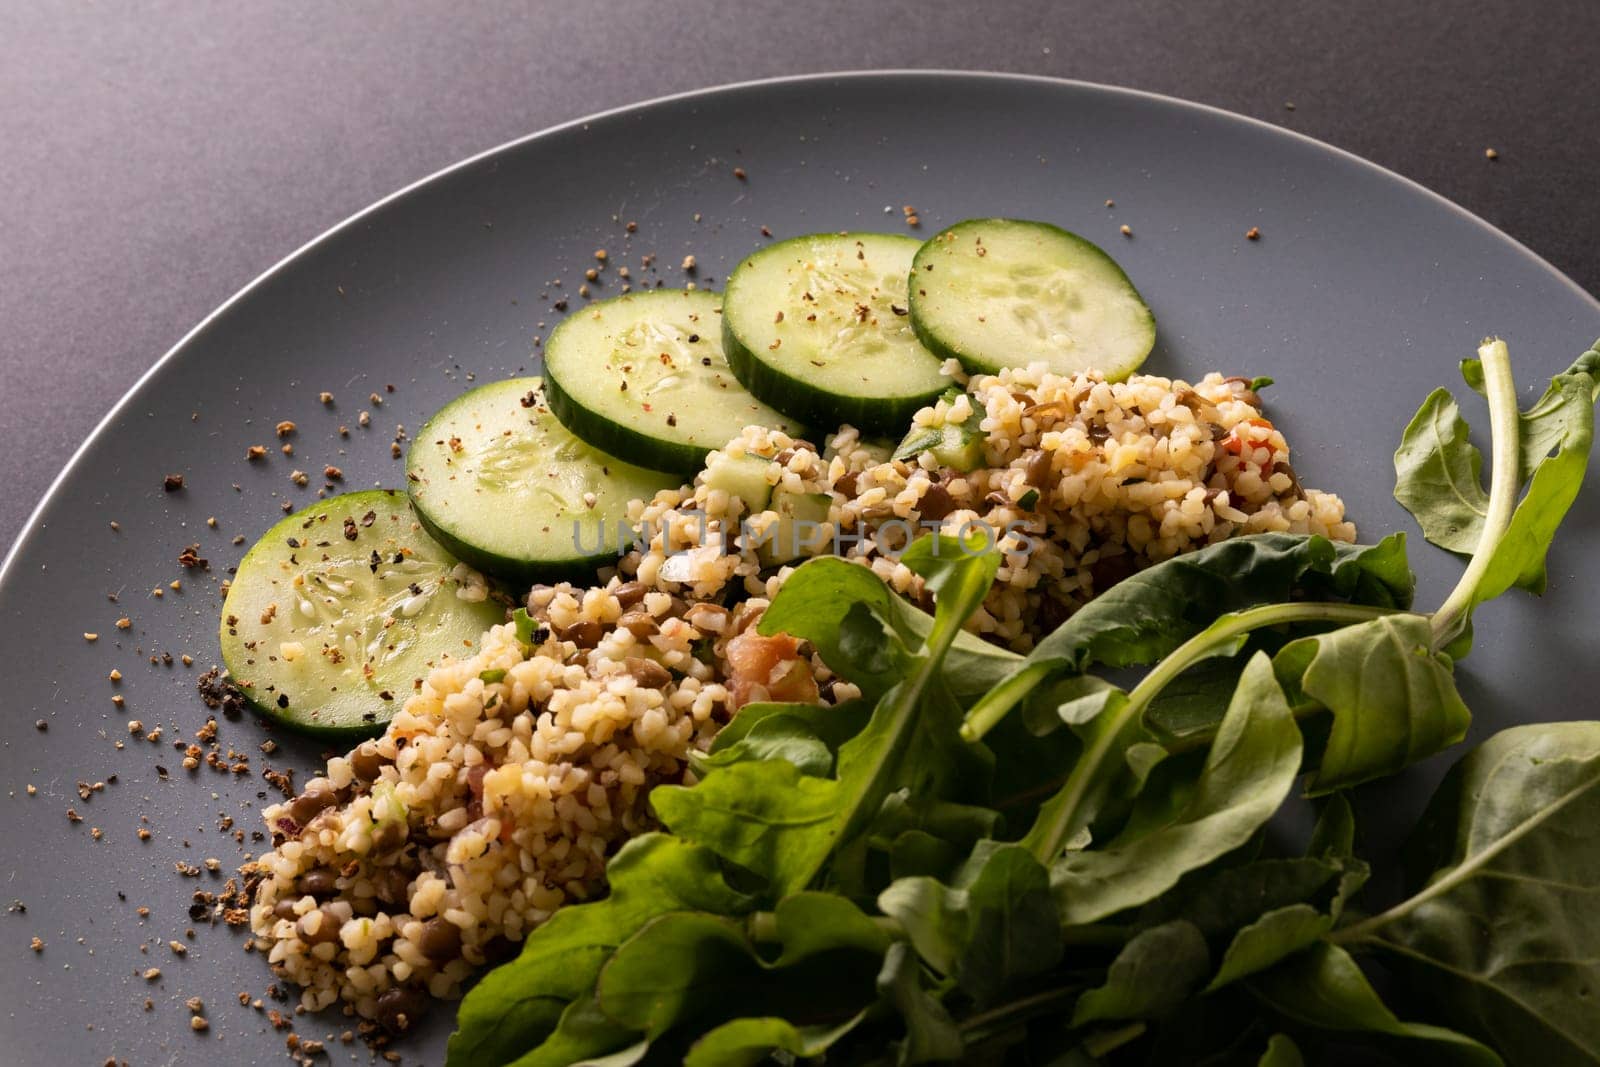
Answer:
[0,74,1600,1065]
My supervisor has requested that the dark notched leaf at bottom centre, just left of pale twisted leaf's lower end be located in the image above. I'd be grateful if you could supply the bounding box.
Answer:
[878,845,1062,1005]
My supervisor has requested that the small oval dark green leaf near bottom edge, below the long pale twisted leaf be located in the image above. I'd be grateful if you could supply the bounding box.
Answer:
[1072,918,1211,1027]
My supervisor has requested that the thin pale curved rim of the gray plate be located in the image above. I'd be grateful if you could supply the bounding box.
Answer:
[0,67,1600,587]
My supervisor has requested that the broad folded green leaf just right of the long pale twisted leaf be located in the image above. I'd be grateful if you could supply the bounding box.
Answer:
[1274,614,1472,793]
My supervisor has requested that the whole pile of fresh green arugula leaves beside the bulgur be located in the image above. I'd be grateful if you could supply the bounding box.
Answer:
[448,342,1600,1067]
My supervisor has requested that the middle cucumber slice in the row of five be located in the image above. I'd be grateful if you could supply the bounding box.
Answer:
[544,290,803,474]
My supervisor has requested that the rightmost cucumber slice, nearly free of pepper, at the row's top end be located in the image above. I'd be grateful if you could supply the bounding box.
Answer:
[910,219,1155,379]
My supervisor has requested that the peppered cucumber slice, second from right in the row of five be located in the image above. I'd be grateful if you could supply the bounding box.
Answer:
[722,234,950,432]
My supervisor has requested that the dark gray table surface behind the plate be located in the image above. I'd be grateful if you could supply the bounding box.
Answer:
[0,0,1600,547]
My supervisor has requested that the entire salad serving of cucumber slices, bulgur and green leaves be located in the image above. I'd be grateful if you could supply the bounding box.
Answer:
[209,219,1600,1065]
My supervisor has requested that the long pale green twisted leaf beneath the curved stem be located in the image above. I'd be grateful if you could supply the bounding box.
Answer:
[1049,654,1301,923]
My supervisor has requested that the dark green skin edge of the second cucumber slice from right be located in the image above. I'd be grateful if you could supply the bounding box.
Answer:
[722,232,949,434]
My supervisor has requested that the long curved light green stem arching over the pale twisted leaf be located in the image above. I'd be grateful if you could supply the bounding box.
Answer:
[1029,603,1395,867]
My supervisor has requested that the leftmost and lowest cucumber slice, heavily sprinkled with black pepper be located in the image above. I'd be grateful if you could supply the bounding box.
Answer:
[222,490,506,739]
